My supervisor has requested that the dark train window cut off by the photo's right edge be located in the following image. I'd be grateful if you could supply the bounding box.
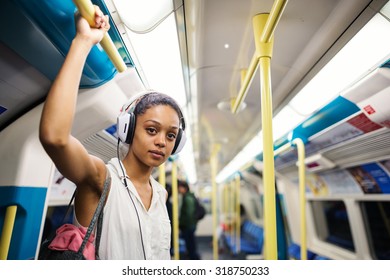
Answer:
[360,201,390,260]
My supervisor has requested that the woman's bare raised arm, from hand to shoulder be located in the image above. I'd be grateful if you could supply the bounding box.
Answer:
[39,7,109,186]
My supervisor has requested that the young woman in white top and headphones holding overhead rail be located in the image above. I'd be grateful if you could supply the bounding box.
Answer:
[39,7,185,259]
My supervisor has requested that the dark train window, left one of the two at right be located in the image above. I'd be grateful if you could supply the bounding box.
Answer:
[312,200,355,251]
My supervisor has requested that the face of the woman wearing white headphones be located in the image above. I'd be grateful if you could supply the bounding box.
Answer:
[130,105,180,167]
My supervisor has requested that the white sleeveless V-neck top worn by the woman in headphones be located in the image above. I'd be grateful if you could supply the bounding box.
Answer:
[99,158,171,260]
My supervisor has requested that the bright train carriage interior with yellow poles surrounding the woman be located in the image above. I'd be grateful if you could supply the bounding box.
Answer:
[0,0,390,260]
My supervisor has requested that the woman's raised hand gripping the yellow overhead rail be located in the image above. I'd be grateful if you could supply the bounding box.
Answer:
[75,5,110,45]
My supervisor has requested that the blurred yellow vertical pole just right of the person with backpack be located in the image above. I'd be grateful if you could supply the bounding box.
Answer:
[210,144,221,260]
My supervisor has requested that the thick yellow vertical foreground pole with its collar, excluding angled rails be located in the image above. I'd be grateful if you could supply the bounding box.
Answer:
[253,14,278,260]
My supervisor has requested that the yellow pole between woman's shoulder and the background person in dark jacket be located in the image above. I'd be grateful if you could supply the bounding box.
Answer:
[171,160,180,260]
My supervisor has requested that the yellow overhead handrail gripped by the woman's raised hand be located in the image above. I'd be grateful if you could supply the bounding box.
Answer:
[73,0,126,72]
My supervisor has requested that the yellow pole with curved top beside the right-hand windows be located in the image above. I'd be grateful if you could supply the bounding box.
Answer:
[293,138,307,260]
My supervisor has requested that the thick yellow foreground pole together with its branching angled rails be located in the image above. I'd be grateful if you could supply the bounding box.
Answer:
[232,0,287,259]
